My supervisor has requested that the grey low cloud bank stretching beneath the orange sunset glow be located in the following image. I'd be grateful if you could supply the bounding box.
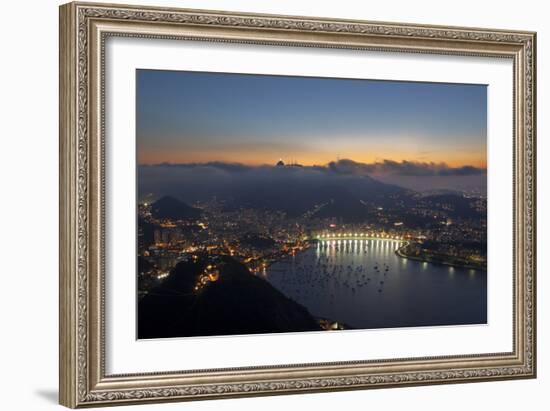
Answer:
[138,159,486,201]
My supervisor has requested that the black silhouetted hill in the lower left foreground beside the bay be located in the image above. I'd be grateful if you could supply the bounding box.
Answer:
[138,257,321,338]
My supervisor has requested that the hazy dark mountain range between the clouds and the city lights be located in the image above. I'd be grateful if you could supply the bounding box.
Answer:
[146,172,481,226]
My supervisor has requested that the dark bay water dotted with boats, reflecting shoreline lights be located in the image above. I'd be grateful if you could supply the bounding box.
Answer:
[263,240,487,328]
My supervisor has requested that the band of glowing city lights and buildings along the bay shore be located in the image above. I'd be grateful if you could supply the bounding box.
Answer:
[138,191,486,300]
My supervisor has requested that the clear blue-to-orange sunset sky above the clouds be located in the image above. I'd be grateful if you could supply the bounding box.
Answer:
[136,70,487,168]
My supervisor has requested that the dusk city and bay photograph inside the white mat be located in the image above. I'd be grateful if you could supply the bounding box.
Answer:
[135,68,487,339]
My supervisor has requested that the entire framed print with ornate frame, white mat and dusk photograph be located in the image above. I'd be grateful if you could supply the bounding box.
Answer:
[60,3,536,408]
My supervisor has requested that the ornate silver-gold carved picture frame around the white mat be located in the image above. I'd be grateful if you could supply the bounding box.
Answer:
[60,3,536,408]
